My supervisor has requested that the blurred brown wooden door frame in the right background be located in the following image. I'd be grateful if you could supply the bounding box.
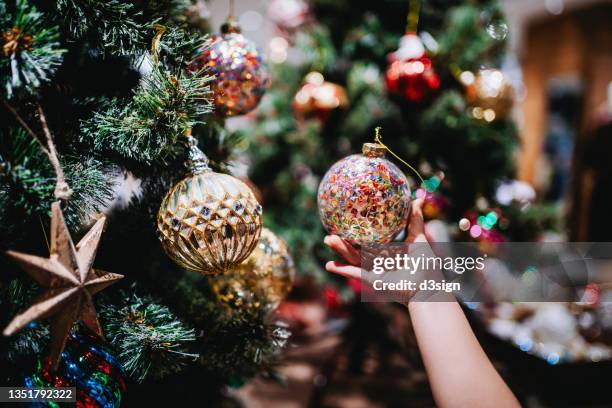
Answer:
[518,4,612,240]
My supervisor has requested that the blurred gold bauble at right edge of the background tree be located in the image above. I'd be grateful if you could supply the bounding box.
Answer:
[460,69,514,122]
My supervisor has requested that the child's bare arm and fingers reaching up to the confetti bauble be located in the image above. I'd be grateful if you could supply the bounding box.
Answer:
[325,200,520,408]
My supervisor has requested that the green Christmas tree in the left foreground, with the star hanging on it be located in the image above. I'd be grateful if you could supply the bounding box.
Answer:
[0,0,288,406]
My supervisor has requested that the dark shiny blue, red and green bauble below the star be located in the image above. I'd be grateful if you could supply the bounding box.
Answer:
[24,325,126,408]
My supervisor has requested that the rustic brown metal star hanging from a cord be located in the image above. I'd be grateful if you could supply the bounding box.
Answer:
[3,202,123,367]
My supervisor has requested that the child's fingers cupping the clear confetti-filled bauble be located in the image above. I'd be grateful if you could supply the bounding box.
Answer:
[323,199,428,283]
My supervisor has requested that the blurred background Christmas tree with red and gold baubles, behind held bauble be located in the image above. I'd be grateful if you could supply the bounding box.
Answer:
[239,0,551,279]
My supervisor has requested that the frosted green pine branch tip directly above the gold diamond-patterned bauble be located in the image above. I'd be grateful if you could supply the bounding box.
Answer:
[81,55,212,164]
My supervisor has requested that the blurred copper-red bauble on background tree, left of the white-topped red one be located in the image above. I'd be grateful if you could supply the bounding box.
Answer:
[293,72,348,121]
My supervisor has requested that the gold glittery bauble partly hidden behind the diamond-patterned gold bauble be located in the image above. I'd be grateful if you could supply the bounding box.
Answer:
[210,228,295,310]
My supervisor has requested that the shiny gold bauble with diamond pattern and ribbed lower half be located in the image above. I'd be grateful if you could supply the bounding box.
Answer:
[157,136,262,275]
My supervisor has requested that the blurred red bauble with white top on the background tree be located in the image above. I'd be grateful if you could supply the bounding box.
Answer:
[385,34,440,102]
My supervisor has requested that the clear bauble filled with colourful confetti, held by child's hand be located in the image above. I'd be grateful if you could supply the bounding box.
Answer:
[318,143,410,245]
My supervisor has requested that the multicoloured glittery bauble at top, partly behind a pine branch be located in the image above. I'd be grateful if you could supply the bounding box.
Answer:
[189,18,270,116]
